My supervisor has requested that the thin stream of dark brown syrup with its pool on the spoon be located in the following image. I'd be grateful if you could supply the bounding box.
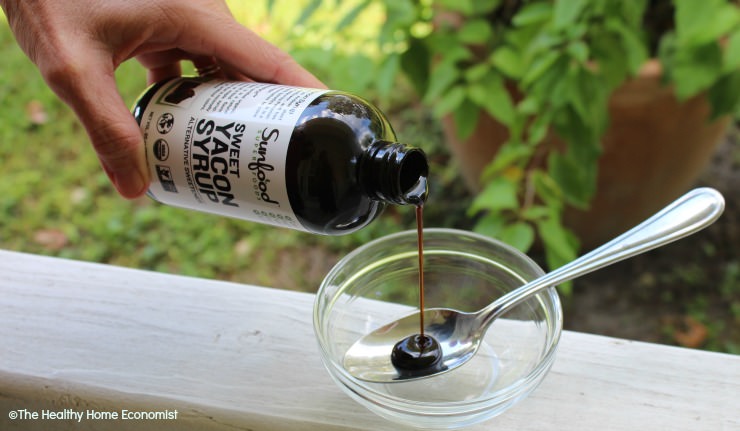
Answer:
[391,202,442,376]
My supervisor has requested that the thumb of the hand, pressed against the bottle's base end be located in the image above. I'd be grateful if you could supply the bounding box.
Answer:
[48,62,149,199]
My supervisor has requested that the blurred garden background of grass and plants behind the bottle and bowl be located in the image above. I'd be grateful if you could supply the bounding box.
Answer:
[0,0,740,354]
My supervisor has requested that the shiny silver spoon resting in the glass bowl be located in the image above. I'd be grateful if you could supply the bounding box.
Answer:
[343,188,725,383]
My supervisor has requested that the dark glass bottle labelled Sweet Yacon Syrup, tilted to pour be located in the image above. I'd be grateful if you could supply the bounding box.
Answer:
[133,78,428,235]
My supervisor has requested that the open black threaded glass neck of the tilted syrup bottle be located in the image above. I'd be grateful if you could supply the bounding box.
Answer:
[359,141,429,206]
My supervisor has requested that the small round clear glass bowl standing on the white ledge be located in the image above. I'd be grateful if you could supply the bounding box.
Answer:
[314,229,562,429]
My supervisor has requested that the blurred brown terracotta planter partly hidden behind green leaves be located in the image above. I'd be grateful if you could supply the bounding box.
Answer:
[443,61,730,249]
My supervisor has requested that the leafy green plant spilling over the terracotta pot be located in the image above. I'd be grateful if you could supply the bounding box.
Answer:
[320,0,740,284]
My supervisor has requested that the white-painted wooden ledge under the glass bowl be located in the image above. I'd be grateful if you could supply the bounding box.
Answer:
[0,251,740,431]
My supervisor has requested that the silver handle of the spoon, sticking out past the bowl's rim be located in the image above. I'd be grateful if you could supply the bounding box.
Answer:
[480,187,725,328]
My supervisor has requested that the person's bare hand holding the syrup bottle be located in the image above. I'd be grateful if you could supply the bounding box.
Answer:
[0,0,324,198]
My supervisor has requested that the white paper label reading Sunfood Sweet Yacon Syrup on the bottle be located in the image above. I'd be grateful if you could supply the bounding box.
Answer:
[141,78,325,230]
